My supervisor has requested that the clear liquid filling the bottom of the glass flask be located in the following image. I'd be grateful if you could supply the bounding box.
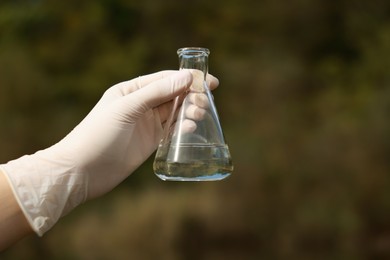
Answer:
[153,143,233,181]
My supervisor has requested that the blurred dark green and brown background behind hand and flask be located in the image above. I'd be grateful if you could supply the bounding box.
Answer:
[0,0,390,259]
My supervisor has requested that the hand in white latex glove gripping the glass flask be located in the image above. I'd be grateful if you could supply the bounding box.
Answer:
[0,70,218,236]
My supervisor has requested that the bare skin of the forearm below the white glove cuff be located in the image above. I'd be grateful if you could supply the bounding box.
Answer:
[0,169,33,251]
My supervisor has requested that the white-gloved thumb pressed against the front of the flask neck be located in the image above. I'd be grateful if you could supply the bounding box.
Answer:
[123,70,192,114]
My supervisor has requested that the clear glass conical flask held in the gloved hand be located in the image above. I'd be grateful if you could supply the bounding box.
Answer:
[153,48,233,181]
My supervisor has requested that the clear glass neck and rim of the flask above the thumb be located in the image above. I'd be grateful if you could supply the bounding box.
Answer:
[177,47,210,79]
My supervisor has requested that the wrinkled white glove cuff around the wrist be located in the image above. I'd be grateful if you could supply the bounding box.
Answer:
[0,148,87,236]
